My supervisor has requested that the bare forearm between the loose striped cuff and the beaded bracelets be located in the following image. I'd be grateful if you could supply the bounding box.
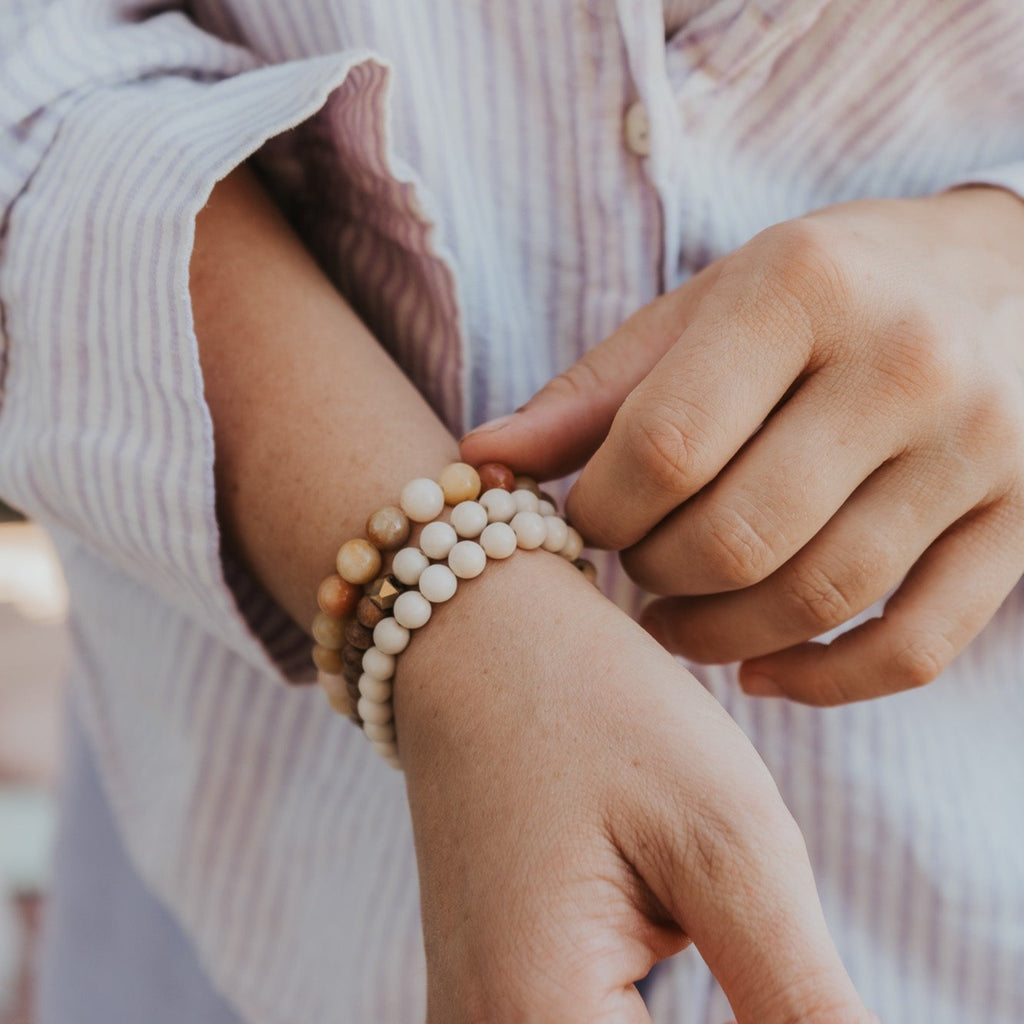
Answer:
[190,166,457,627]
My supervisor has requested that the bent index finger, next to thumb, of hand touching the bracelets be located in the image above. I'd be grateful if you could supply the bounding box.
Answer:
[567,229,815,550]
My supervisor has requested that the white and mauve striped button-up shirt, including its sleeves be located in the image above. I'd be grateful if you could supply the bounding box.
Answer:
[0,0,1024,1024]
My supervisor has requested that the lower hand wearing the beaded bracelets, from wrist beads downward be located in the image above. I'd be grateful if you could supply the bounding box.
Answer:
[395,553,873,1024]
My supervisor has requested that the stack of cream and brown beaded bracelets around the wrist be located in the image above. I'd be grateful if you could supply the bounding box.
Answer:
[312,462,597,768]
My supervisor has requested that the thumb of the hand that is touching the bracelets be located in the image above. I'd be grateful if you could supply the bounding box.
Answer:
[462,263,719,479]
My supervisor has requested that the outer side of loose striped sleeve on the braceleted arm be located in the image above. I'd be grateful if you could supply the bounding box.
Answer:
[0,0,384,672]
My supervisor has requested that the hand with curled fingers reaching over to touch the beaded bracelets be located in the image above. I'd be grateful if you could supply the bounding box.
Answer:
[463,187,1024,705]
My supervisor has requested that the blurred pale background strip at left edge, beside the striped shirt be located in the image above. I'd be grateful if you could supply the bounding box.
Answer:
[0,504,69,1024]
